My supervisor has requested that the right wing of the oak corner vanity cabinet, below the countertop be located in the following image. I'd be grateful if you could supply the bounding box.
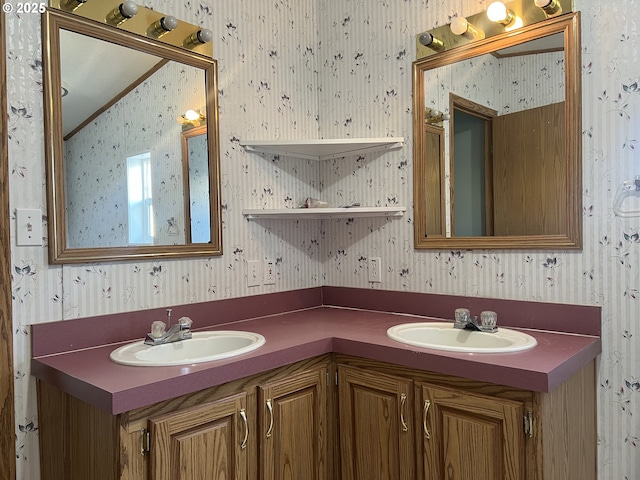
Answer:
[336,355,597,480]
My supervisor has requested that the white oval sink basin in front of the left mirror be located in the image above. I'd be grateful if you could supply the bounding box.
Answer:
[110,330,265,367]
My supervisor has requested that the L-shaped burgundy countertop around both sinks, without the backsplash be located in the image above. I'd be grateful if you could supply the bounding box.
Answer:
[31,306,601,414]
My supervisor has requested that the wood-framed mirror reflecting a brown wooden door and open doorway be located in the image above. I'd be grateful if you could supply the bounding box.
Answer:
[413,12,582,249]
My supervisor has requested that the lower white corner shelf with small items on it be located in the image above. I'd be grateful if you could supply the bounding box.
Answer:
[242,207,407,220]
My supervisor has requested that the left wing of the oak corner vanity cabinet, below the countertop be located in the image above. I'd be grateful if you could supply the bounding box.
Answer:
[38,355,334,480]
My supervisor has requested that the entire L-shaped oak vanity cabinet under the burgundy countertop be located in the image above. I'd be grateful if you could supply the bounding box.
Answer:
[38,354,597,480]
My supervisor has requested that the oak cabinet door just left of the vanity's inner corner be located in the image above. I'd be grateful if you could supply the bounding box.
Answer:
[258,367,327,480]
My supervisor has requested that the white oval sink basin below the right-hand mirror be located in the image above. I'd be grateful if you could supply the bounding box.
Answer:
[387,322,538,353]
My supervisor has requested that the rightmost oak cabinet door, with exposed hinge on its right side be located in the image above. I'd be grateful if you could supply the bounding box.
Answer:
[416,384,525,480]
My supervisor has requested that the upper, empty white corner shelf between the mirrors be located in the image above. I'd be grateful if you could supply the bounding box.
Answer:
[240,137,404,160]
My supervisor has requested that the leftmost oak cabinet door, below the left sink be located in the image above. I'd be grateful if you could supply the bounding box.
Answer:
[149,393,249,480]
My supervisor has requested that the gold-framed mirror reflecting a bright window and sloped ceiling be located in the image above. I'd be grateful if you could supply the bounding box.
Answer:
[42,9,222,264]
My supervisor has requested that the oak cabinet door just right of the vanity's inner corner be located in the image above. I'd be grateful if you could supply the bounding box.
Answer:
[338,365,416,480]
